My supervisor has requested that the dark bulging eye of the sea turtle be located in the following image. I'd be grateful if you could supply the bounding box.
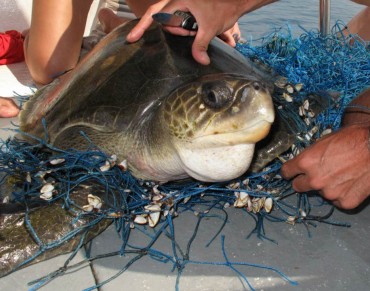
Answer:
[202,82,233,109]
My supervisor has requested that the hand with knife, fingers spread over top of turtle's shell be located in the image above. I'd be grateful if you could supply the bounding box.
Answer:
[127,0,277,65]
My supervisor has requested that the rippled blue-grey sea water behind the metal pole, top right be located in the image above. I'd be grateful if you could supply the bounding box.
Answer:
[239,0,365,39]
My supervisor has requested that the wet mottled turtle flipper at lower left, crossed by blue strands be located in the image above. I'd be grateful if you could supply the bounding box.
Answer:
[0,187,112,277]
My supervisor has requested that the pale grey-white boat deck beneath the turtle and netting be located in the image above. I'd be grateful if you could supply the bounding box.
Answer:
[0,0,370,291]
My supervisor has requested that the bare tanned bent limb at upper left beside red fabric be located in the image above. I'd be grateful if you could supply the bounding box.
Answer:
[25,0,92,83]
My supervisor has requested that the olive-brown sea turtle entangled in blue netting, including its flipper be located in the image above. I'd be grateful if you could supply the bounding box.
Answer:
[0,21,274,275]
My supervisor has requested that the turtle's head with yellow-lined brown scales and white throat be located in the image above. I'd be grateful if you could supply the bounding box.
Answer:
[163,74,274,182]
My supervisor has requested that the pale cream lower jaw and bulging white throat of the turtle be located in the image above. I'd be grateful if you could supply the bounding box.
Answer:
[176,120,271,182]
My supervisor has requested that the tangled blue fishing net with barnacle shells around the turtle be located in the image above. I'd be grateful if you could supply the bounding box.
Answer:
[0,22,370,290]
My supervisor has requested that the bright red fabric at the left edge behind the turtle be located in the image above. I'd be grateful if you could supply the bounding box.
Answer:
[0,30,24,65]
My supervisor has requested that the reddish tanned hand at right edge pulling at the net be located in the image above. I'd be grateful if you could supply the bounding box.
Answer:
[281,125,370,209]
